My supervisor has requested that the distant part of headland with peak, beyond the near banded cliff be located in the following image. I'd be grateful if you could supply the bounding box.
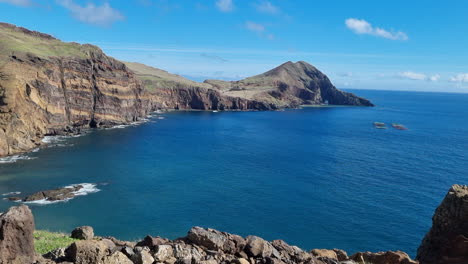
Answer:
[127,61,373,110]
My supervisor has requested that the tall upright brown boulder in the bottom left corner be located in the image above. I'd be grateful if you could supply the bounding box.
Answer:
[0,205,36,263]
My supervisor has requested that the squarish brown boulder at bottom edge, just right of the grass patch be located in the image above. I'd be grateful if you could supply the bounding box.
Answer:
[65,240,108,264]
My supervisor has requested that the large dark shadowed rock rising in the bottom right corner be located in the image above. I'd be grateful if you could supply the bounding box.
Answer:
[416,185,468,264]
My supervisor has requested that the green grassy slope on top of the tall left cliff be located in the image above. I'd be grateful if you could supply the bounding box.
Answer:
[0,25,99,58]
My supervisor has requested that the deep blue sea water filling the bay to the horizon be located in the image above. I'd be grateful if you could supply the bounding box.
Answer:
[0,90,468,256]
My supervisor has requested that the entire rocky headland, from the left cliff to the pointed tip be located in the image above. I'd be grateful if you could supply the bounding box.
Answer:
[0,23,372,156]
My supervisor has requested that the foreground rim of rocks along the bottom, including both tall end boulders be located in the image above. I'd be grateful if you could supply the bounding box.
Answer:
[0,185,468,264]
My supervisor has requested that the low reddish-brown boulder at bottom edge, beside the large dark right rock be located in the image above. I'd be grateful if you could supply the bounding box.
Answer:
[350,251,416,264]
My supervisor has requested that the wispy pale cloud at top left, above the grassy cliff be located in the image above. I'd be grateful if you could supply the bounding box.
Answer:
[57,0,125,26]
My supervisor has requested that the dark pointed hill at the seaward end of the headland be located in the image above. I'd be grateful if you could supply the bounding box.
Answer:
[205,61,373,108]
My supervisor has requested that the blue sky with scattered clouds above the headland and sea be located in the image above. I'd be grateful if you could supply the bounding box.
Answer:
[0,0,468,92]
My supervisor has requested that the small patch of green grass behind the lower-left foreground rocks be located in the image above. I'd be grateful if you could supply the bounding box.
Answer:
[34,230,77,254]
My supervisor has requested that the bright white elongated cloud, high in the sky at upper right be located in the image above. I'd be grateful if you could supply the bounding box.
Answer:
[345,18,408,40]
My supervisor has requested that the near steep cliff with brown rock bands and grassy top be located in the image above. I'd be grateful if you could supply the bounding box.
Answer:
[0,24,151,156]
